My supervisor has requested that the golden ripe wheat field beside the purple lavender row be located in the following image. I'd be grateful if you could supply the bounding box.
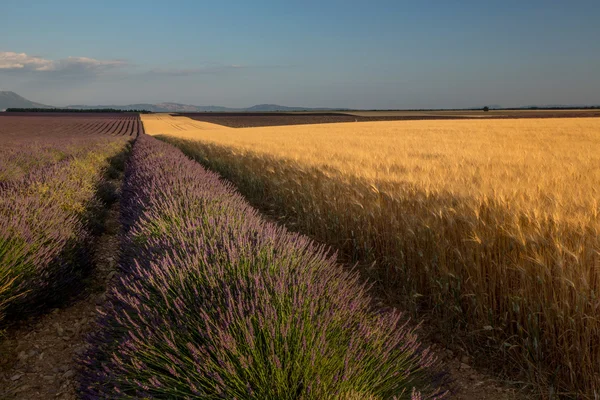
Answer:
[142,115,600,398]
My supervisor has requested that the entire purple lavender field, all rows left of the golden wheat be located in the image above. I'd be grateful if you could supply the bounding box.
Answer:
[0,115,447,400]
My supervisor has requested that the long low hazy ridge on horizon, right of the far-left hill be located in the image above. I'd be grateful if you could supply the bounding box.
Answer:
[67,103,339,112]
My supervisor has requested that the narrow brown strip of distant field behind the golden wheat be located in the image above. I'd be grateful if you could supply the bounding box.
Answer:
[174,110,600,128]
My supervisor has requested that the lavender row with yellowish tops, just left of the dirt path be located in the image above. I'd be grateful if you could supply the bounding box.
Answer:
[0,138,127,327]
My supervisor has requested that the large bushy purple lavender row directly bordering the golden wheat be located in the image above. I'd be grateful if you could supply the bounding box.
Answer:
[80,135,446,399]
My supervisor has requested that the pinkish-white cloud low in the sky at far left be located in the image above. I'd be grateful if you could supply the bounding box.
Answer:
[0,51,127,73]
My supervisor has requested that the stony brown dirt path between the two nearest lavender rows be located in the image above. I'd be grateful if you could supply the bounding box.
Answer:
[0,202,119,400]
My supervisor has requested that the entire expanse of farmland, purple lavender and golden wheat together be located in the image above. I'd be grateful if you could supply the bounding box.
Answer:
[0,109,600,399]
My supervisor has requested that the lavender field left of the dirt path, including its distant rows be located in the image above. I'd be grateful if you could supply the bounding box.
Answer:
[0,116,141,329]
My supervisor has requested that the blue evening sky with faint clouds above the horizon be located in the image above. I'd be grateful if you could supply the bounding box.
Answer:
[0,0,600,109]
